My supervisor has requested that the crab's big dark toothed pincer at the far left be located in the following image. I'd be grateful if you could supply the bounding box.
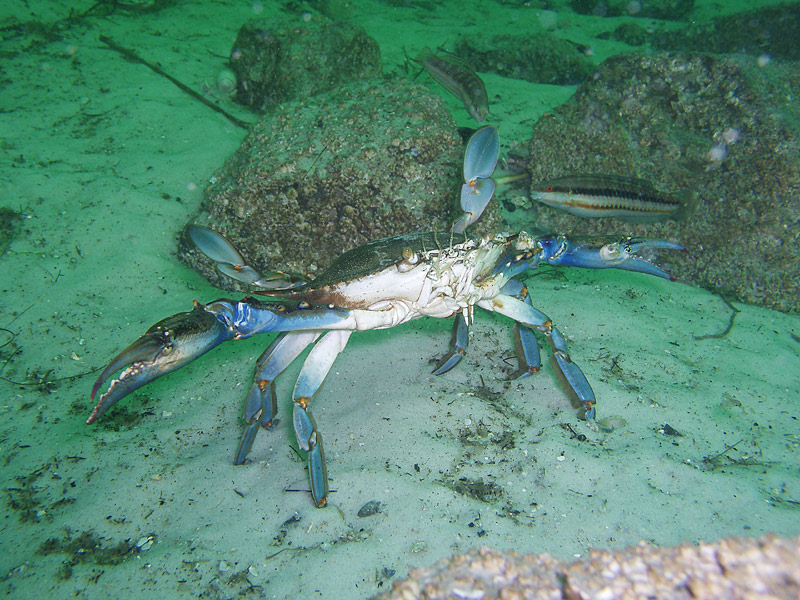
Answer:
[86,302,233,425]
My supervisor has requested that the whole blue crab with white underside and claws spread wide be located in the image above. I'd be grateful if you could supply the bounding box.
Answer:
[87,127,682,507]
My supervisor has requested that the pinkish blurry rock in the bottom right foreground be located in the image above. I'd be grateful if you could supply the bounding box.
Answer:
[373,535,800,600]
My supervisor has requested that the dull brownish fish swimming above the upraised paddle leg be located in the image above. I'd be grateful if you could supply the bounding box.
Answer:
[412,48,489,123]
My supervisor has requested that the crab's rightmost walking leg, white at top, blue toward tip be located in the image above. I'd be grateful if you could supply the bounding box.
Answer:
[479,294,596,420]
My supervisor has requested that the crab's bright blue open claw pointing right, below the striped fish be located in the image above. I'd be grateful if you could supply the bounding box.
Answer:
[539,235,686,281]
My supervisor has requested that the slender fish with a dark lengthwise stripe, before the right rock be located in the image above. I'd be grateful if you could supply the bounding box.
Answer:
[531,175,692,223]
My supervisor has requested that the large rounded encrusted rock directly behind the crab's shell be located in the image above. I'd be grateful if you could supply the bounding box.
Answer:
[179,81,497,288]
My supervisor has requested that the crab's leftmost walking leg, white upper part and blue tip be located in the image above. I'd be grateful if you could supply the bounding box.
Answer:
[233,331,320,465]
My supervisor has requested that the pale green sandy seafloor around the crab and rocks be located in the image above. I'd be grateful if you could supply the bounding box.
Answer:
[0,0,800,598]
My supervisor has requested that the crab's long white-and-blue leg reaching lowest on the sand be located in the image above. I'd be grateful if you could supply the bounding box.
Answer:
[292,330,353,507]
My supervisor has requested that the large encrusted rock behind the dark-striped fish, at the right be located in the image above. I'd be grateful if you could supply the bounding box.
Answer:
[526,54,800,312]
